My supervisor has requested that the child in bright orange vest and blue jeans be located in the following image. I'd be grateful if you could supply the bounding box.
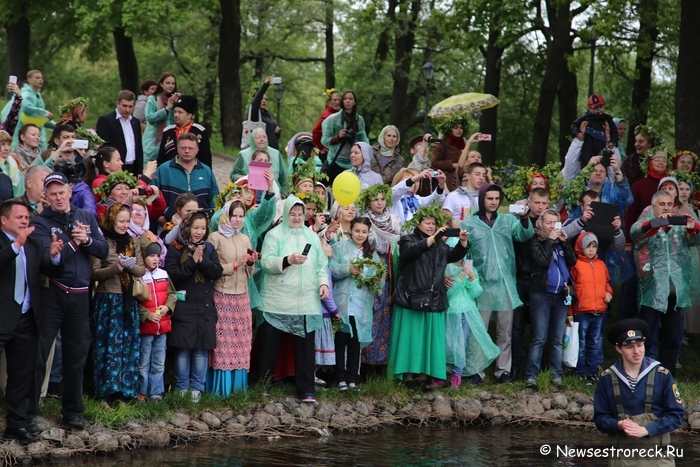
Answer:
[567,232,612,385]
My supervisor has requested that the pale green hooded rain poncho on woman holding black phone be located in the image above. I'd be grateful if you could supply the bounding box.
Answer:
[257,196,328,337]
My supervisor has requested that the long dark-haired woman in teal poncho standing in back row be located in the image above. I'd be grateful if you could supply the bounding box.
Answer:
[321,91,369,185]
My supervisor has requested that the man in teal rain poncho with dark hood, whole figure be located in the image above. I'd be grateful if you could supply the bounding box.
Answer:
[460,184,535,383]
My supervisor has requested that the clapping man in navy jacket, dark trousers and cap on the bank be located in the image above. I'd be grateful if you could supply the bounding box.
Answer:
[27,172,109,431]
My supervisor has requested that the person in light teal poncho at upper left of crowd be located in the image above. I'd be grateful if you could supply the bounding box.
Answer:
[0,70,55,151]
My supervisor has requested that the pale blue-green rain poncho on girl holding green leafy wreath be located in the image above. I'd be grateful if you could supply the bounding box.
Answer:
[330,240,386,347]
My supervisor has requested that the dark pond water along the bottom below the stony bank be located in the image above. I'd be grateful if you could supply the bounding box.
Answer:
[82,427,700,467]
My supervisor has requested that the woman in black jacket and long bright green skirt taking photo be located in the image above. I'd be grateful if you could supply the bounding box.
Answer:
[389,206,468,389]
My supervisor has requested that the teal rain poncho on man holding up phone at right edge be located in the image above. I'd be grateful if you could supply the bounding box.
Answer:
[630,210,697,313]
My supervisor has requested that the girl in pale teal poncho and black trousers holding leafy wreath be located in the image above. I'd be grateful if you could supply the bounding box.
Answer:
[330,217,385,391]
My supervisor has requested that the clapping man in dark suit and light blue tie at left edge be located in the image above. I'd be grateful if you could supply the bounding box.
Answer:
[0,199,63,443]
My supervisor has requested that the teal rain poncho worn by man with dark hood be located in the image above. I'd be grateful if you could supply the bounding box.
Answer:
[460,214,535,311]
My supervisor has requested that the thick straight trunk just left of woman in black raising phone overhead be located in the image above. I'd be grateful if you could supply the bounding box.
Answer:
[219,0,243,148]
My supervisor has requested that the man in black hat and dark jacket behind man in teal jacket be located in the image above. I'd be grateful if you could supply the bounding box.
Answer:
[158,96,211,168]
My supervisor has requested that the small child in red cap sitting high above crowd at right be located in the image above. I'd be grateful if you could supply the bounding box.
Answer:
[571,94,618,167]
